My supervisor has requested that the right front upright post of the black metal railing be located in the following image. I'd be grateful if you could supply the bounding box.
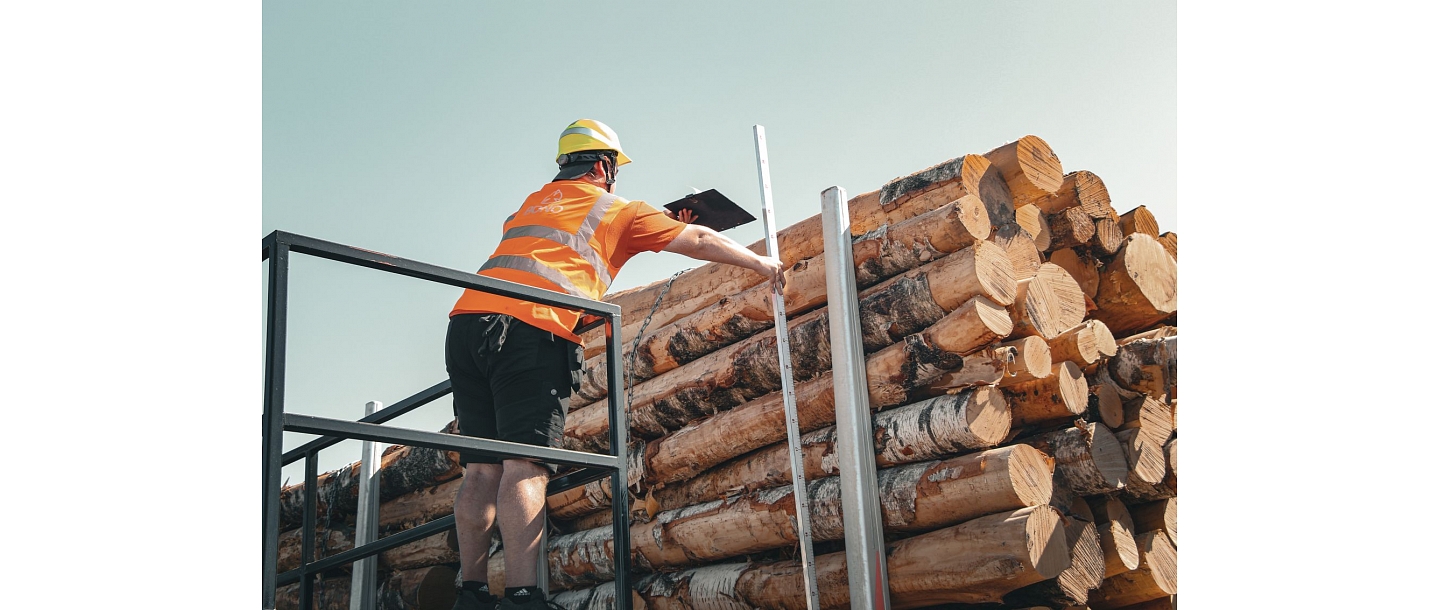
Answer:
[605,314,631,610]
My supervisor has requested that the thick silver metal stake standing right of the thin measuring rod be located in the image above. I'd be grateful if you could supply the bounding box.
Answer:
[821,187,890,609]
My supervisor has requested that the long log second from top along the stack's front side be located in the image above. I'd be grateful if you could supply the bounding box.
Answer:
[577,196,990,401]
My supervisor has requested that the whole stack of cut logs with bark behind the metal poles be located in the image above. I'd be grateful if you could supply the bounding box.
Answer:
[272,135,1178,609]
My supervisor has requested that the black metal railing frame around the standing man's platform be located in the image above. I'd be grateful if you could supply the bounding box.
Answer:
[261,232,631,610]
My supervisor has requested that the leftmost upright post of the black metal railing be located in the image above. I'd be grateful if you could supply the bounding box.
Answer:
[261,239,289,610]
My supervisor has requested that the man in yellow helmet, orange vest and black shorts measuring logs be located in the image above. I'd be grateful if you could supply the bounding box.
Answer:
[445,119,785,610]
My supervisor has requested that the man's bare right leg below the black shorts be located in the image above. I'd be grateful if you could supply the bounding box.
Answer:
[497,459,550,588]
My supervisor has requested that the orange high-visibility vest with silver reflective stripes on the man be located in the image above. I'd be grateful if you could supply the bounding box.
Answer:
[451,180,629,342]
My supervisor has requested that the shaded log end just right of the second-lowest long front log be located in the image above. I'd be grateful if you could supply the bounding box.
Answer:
[1020,422,1129,495]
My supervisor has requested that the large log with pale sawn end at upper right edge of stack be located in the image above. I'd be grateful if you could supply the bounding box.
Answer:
[1094,233,1176,334]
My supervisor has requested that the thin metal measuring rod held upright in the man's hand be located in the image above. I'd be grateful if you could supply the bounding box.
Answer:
[755,125,819,610]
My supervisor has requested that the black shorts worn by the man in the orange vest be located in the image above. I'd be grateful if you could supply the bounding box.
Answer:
[445,314,580,470]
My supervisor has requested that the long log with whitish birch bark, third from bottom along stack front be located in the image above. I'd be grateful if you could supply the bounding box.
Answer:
[645,387,1009,515]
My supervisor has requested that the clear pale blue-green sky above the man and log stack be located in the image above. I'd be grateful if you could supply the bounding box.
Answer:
[256,1,1179,482]
